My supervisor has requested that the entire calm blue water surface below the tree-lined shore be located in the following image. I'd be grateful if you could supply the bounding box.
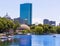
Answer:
[0,34,60,46]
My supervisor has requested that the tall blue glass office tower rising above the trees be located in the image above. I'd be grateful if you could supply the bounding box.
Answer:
[20,3,32,25]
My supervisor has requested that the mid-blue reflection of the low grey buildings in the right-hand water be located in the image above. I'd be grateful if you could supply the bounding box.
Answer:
[43,36,55,46]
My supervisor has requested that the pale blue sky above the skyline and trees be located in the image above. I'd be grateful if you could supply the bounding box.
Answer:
[0,0,60,24]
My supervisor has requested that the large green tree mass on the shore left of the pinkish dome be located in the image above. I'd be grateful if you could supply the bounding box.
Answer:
[0,18,19,33]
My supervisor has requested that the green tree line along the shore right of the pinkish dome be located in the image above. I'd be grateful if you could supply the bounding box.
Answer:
[31,24,60,35]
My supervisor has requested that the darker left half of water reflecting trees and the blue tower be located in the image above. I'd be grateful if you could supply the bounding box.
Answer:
[0,35,31,46]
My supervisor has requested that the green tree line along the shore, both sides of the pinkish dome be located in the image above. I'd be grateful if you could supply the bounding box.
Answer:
[0,17,60,35]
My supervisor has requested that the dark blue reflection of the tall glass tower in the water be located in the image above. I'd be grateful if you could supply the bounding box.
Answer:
[20,35,31,46]
